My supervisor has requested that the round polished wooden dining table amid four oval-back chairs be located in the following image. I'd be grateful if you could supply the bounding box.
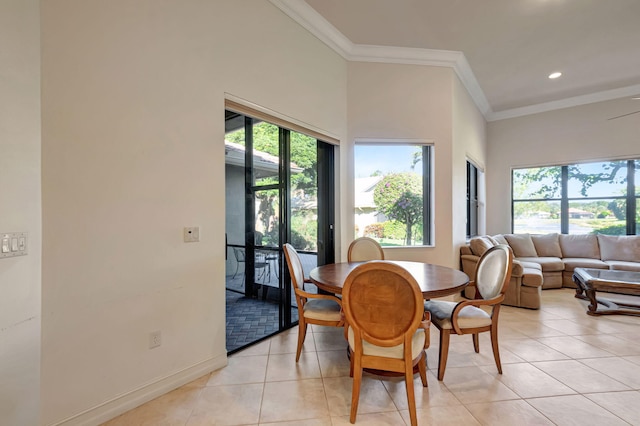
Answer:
[309,260,469,299]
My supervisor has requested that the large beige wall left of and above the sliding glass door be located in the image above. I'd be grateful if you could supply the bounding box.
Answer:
[42,0,347,424]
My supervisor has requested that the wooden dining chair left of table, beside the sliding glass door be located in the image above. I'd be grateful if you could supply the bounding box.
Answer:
[283,243,344,362]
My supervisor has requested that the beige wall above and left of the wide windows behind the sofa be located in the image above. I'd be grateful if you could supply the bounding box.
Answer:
[486,98,640,234]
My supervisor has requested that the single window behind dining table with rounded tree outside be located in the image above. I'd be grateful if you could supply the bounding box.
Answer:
[354,143,432,246]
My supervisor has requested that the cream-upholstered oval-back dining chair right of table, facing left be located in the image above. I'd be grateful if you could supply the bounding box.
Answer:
[424,244,513,380]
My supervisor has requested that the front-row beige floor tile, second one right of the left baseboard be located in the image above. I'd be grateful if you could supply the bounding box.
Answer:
[186,384,264,426]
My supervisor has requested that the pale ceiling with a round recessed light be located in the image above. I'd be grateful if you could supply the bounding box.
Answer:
[271,0,640,119]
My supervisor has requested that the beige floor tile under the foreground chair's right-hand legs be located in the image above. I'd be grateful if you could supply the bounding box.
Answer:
[382,371,461,410]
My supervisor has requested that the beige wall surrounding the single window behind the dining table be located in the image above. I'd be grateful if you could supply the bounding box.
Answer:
[341,62,457,266]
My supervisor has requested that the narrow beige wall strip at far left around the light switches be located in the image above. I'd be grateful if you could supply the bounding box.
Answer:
[0,0,41,425]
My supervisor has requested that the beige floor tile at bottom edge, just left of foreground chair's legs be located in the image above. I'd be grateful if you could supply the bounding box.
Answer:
[260,379,329,423]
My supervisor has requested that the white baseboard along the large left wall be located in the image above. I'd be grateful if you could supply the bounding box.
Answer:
[50,354,227,426]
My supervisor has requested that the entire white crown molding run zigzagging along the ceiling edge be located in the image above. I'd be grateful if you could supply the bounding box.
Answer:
[269,0,640,121]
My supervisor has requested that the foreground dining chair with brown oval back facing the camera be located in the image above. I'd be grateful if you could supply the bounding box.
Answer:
[342,261,429,425]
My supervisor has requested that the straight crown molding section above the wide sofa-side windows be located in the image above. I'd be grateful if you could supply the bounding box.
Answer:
[485,84,640,121]
